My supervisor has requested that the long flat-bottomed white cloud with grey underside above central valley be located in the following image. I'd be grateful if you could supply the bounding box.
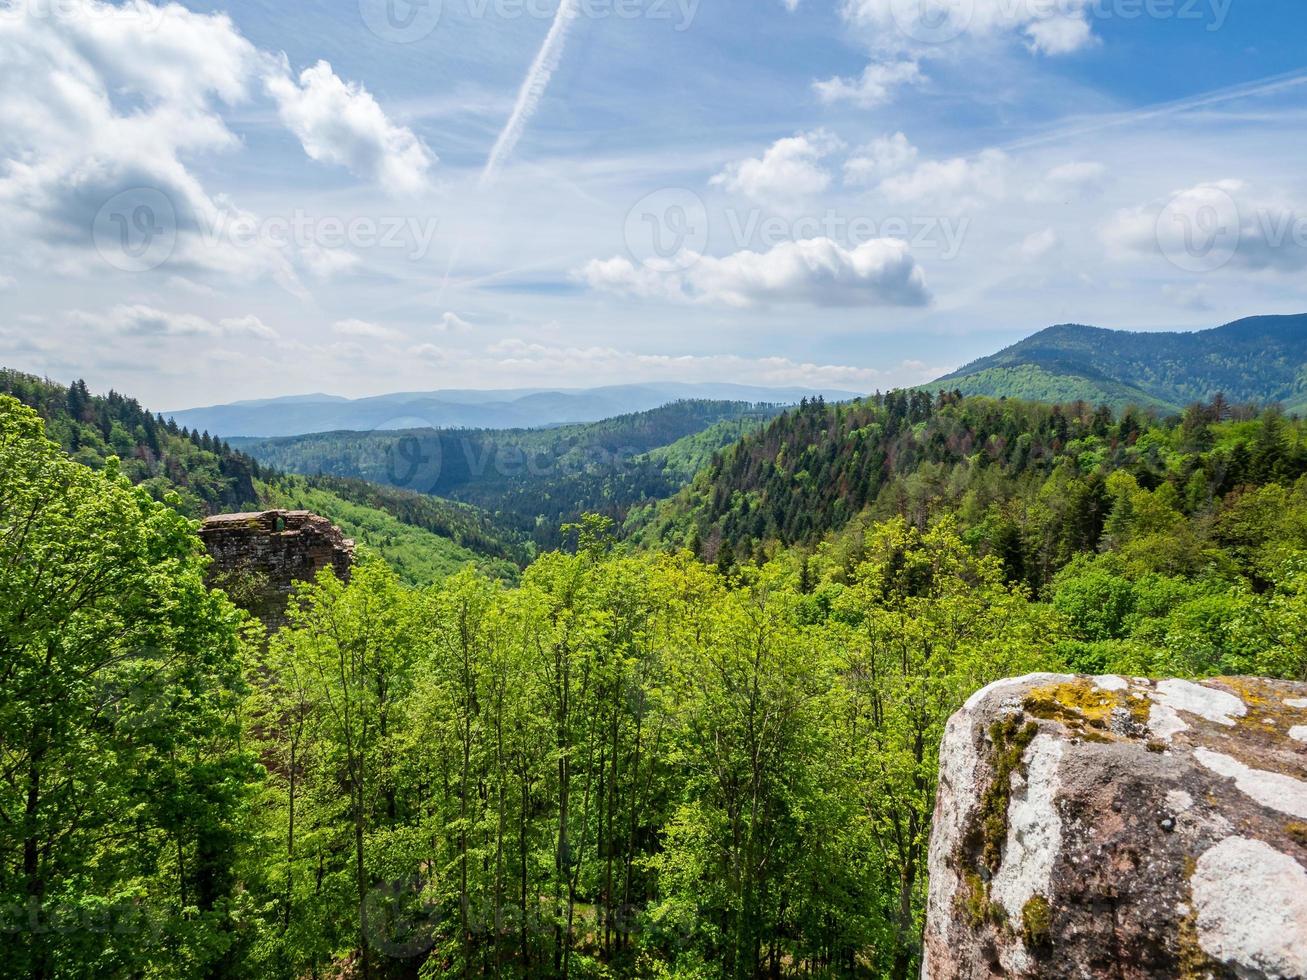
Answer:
[578,238,929,307]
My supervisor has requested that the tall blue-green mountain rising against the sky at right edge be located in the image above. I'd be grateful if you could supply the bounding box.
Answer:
[927,315,1307,412]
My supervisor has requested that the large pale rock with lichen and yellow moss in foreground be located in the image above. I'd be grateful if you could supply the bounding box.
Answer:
[923,674,1307,980]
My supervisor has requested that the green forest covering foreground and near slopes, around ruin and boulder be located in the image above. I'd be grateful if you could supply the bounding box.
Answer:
[0,379,1307,980]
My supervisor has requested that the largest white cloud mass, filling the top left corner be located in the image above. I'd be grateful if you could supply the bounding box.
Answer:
[0,0,259,264]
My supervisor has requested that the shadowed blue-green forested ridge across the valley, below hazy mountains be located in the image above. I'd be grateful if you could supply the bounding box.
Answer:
[234,401,782,549]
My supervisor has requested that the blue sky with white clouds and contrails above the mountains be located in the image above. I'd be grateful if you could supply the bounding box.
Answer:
[0,0,1307,410]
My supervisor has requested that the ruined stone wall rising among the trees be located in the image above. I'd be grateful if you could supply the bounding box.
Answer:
[200,511,354,631]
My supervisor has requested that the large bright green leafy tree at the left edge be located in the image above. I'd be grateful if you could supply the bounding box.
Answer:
[0,397,256,976]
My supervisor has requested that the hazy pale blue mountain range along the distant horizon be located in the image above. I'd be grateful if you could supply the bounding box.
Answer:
[163,383,859,438]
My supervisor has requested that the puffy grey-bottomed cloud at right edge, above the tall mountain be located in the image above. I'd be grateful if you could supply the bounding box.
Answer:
[1099,179,1307,274]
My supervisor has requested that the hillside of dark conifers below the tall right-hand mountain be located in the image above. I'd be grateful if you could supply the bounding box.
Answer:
[631,392,1307,589]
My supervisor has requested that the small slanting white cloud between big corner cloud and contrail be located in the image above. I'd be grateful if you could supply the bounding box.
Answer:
[264,61,435,195]
